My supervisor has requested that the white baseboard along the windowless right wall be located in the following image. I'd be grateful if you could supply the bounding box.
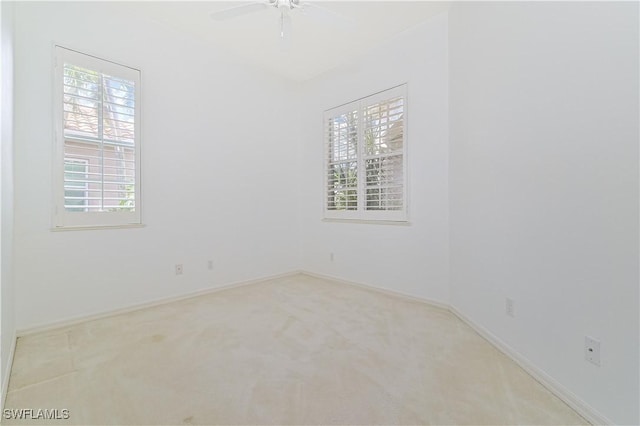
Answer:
[449,306,614,425]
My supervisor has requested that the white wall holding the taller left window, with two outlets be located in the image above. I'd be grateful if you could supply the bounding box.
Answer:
[15,2,299,329]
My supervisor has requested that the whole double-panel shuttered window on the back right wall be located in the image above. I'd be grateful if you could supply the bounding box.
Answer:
[324,85,407,221]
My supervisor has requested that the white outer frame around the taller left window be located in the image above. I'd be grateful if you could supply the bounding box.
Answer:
[52,46,142,230]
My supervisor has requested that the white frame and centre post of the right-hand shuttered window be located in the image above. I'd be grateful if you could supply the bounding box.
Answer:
[322,83,409,223]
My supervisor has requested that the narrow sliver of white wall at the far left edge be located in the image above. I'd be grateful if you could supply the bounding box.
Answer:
[0,1,16,405]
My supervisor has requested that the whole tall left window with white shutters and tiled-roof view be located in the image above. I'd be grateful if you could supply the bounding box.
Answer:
[53,47,141,228]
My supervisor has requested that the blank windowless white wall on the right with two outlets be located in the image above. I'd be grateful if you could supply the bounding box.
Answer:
[449,2,640,424]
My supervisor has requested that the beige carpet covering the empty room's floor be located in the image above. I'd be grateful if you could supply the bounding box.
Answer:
[5,275,586,425]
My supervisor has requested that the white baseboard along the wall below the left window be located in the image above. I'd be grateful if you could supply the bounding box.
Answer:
[17,271,300,337]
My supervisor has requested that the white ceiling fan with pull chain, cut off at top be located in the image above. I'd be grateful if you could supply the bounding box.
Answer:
[211,0,351,49]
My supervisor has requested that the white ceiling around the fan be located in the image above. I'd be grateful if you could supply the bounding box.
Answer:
[127,0,449,81]
